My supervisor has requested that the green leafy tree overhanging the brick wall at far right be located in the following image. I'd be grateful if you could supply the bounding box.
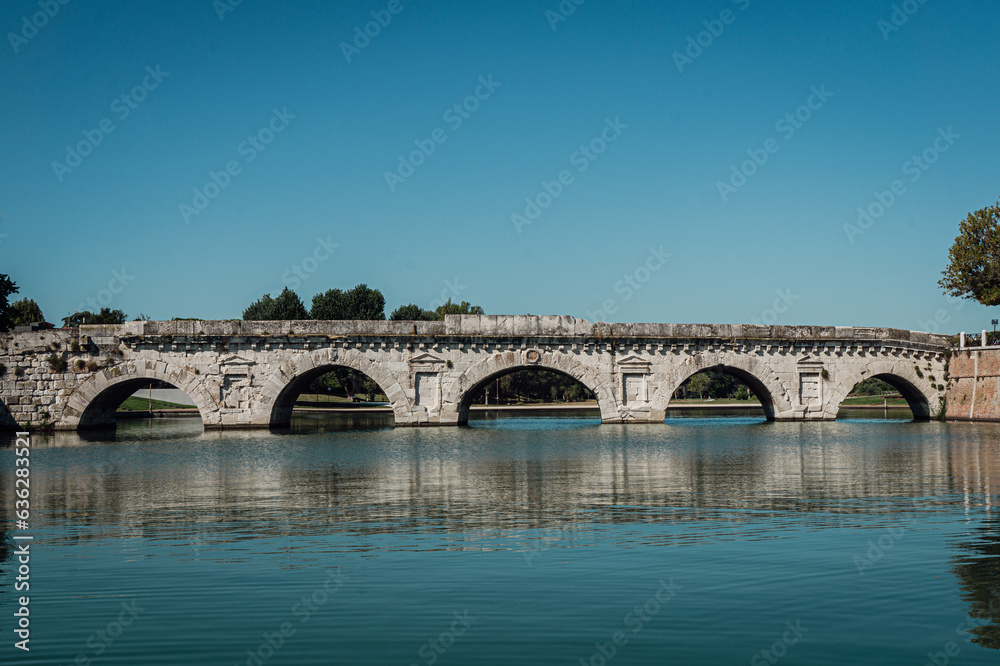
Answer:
[938,196,1000,305]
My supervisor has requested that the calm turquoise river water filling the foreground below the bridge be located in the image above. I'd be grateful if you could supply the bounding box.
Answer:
[0,413,1000,666]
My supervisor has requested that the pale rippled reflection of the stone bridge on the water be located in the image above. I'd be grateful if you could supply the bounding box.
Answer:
[13,423,1000,531]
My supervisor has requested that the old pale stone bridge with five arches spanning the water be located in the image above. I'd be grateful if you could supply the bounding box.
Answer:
[0,315,950,429]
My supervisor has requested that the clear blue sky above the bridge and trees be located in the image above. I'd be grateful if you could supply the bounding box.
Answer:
[0,0,1000,332]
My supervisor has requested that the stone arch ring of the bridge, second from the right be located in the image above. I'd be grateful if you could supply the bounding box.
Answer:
[650,352,792,421]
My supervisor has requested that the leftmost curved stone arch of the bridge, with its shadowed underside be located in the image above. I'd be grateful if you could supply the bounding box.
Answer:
[60,359,222,428]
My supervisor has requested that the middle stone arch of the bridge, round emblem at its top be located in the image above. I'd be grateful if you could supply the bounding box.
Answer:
[444,349,619,425]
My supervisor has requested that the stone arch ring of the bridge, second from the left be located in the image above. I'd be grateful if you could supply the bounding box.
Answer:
[250,349,410,425]
